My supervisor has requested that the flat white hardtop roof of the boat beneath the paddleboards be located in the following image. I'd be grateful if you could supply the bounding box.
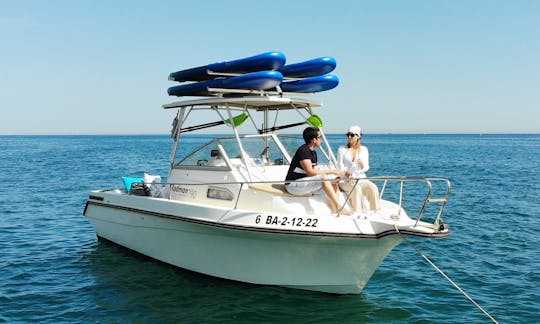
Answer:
[162,96,322,111]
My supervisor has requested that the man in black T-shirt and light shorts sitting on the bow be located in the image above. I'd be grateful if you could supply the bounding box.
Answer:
[285,127,350,214]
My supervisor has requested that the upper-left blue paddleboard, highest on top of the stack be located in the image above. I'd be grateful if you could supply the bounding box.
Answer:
[169,52,286,82]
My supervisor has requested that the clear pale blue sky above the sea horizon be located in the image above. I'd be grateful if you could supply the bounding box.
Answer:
[0,0,540,135]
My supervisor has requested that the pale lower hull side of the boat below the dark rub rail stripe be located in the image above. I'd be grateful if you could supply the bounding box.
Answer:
[85,197,402,294]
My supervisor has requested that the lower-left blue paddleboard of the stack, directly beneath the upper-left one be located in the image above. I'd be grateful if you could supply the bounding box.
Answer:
[167,71,283,97]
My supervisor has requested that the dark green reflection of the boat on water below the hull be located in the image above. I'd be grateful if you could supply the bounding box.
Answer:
[89,240,409,323]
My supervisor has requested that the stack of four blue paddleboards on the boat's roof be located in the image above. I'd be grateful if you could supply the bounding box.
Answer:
[167,52,339,97]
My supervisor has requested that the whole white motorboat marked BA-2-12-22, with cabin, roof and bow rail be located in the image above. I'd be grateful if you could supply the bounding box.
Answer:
[84,57,450,293]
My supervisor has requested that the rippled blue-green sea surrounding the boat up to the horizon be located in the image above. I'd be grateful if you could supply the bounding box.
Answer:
[0,134,540,323]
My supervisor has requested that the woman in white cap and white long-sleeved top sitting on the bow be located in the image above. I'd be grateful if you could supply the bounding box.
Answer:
[338,126,379,211]
